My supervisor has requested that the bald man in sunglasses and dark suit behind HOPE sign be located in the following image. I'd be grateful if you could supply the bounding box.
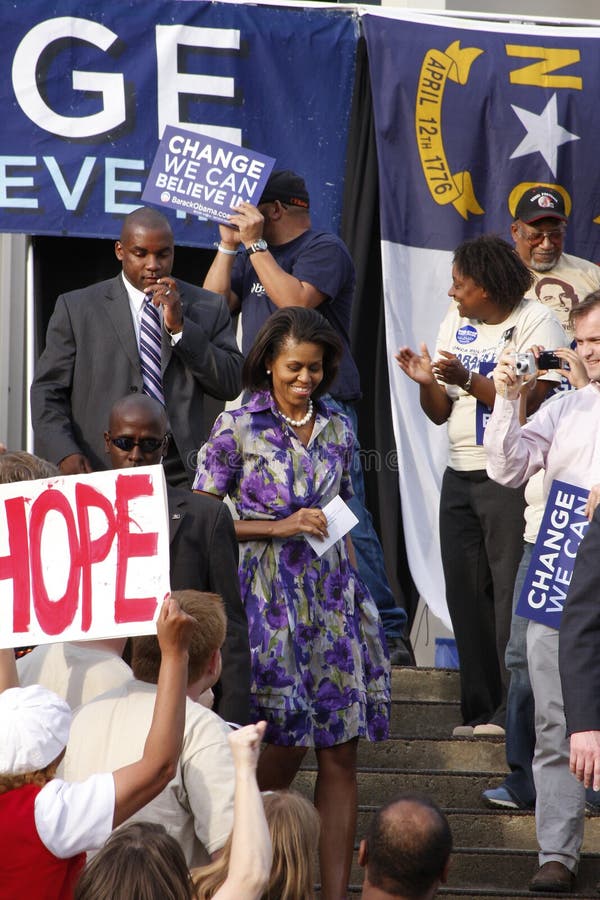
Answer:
[104,394,250,725]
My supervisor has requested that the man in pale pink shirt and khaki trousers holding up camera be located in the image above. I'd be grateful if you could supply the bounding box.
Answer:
[484,291,600,893]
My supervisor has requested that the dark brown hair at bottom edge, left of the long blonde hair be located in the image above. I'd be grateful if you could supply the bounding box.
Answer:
[74,822,196,900]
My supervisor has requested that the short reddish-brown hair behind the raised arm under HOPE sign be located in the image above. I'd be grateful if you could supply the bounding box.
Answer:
[131,590,227,684]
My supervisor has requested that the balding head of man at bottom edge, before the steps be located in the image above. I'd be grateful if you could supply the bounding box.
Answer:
[366,794,452,900]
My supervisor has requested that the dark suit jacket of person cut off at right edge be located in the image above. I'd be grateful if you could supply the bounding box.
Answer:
[559,506,600,734]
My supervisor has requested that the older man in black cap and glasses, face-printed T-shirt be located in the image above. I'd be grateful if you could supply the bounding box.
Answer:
[511,185,600,328]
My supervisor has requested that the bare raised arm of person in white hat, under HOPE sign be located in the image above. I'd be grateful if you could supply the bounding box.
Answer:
[113,598,195,828]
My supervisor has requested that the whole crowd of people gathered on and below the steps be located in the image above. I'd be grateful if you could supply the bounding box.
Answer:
[0,171,600,900]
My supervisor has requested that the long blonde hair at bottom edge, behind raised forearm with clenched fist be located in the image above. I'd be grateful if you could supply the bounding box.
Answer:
[192,791,321,900]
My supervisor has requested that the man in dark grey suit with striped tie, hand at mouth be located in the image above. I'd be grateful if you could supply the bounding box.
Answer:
[31,207,243,486]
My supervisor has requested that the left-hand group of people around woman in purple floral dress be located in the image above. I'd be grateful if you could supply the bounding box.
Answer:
[0,171,406,900]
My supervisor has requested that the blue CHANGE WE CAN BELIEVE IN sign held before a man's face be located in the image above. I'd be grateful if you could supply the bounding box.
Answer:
[142,125,275,222]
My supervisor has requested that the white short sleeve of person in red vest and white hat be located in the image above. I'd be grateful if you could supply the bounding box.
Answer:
[35,773,115,859]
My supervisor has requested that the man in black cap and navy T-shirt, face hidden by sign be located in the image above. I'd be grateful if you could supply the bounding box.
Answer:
[204,170,411,664]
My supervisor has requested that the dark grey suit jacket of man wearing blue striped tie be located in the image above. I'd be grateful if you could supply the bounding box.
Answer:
[31,275,243,479]
